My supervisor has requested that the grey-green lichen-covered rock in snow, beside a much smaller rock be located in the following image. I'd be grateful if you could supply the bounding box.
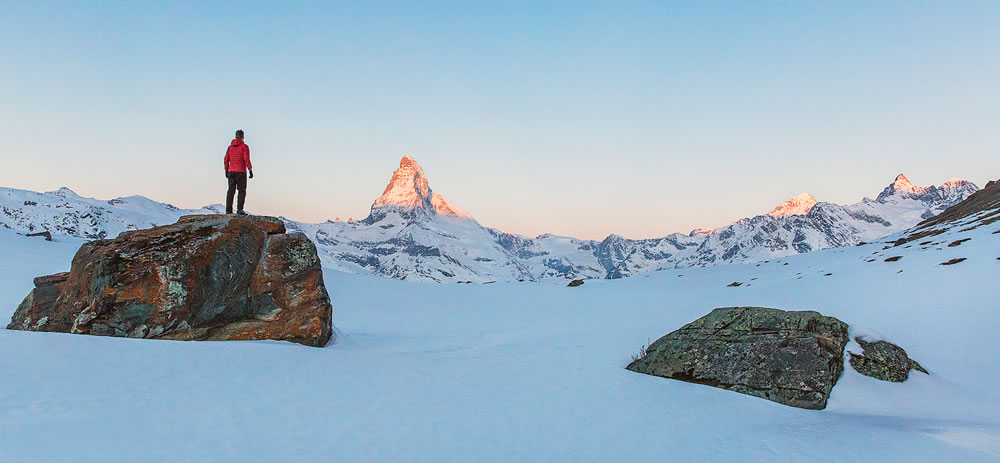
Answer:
[628,307,848,410]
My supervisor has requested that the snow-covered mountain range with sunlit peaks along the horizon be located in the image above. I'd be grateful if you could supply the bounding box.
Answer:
[0,156,979,282]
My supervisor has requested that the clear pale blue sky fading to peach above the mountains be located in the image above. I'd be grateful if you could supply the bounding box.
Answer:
[0,1,1000,238]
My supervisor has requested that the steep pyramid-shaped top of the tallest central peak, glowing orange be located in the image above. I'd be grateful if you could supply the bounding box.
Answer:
[367,155,472,222]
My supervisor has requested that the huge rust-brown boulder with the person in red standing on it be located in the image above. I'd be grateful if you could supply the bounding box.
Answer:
[7,215,333,346]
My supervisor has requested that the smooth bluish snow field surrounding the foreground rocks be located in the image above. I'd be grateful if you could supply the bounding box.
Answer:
[0,223,1000,462]
